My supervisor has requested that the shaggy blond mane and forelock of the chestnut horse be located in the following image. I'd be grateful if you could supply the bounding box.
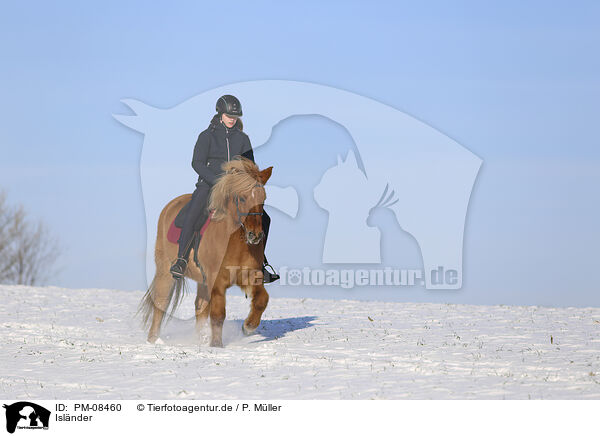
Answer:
[208,156,262,221]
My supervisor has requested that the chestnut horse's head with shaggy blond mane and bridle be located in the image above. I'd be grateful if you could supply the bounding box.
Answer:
[209,158,273,245]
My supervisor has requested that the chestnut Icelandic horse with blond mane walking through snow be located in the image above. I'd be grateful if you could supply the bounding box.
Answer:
[139,158,273,347]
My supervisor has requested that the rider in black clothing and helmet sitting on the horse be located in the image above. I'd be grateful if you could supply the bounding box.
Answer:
[170,95,279,283]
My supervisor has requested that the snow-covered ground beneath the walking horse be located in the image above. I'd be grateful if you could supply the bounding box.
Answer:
[0,285,600,399]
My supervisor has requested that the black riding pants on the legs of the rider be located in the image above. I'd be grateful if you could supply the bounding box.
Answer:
[177,183,271,258]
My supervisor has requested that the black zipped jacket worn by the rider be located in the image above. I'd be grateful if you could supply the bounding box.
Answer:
[192,115,254,186]
